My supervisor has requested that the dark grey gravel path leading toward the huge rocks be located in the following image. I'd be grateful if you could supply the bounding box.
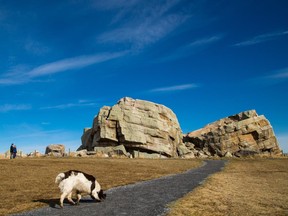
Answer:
[12,160,225,216]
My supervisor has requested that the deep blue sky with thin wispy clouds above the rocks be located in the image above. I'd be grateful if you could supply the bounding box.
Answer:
[0,0,288,153]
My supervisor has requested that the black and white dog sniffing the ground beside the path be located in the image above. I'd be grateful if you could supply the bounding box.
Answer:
[55,170,106,208]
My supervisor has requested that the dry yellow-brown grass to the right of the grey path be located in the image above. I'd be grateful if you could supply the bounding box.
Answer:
[168,158,288,216]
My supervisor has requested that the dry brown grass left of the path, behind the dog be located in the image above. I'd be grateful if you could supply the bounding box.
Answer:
[0,158,201,215]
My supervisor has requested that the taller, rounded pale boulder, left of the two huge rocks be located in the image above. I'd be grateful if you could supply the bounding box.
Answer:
[78,97,182,157]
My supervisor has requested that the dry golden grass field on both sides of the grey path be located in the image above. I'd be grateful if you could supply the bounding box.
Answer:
[0,158,288,216]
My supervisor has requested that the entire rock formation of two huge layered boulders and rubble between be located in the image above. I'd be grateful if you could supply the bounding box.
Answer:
[78,97,282,158]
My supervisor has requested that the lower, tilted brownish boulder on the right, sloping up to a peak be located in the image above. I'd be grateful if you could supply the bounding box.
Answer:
[183,110,281,157]
